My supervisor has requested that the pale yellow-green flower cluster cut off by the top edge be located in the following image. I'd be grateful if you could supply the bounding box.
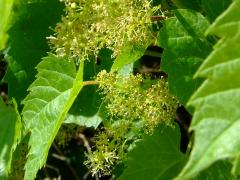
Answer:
[48,0,161,60]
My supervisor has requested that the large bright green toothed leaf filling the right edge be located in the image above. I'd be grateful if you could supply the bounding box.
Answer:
[178,0,240,179]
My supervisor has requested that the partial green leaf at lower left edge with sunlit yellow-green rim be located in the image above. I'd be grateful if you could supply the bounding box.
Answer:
[0,97,22,179]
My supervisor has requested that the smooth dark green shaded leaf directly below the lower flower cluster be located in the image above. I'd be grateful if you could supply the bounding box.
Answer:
[119,126,186,180]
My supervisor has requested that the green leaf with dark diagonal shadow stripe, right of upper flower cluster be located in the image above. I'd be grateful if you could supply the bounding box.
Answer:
[157,10,211,105]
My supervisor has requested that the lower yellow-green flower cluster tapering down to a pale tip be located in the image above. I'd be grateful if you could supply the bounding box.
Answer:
[85,70,178,176]
